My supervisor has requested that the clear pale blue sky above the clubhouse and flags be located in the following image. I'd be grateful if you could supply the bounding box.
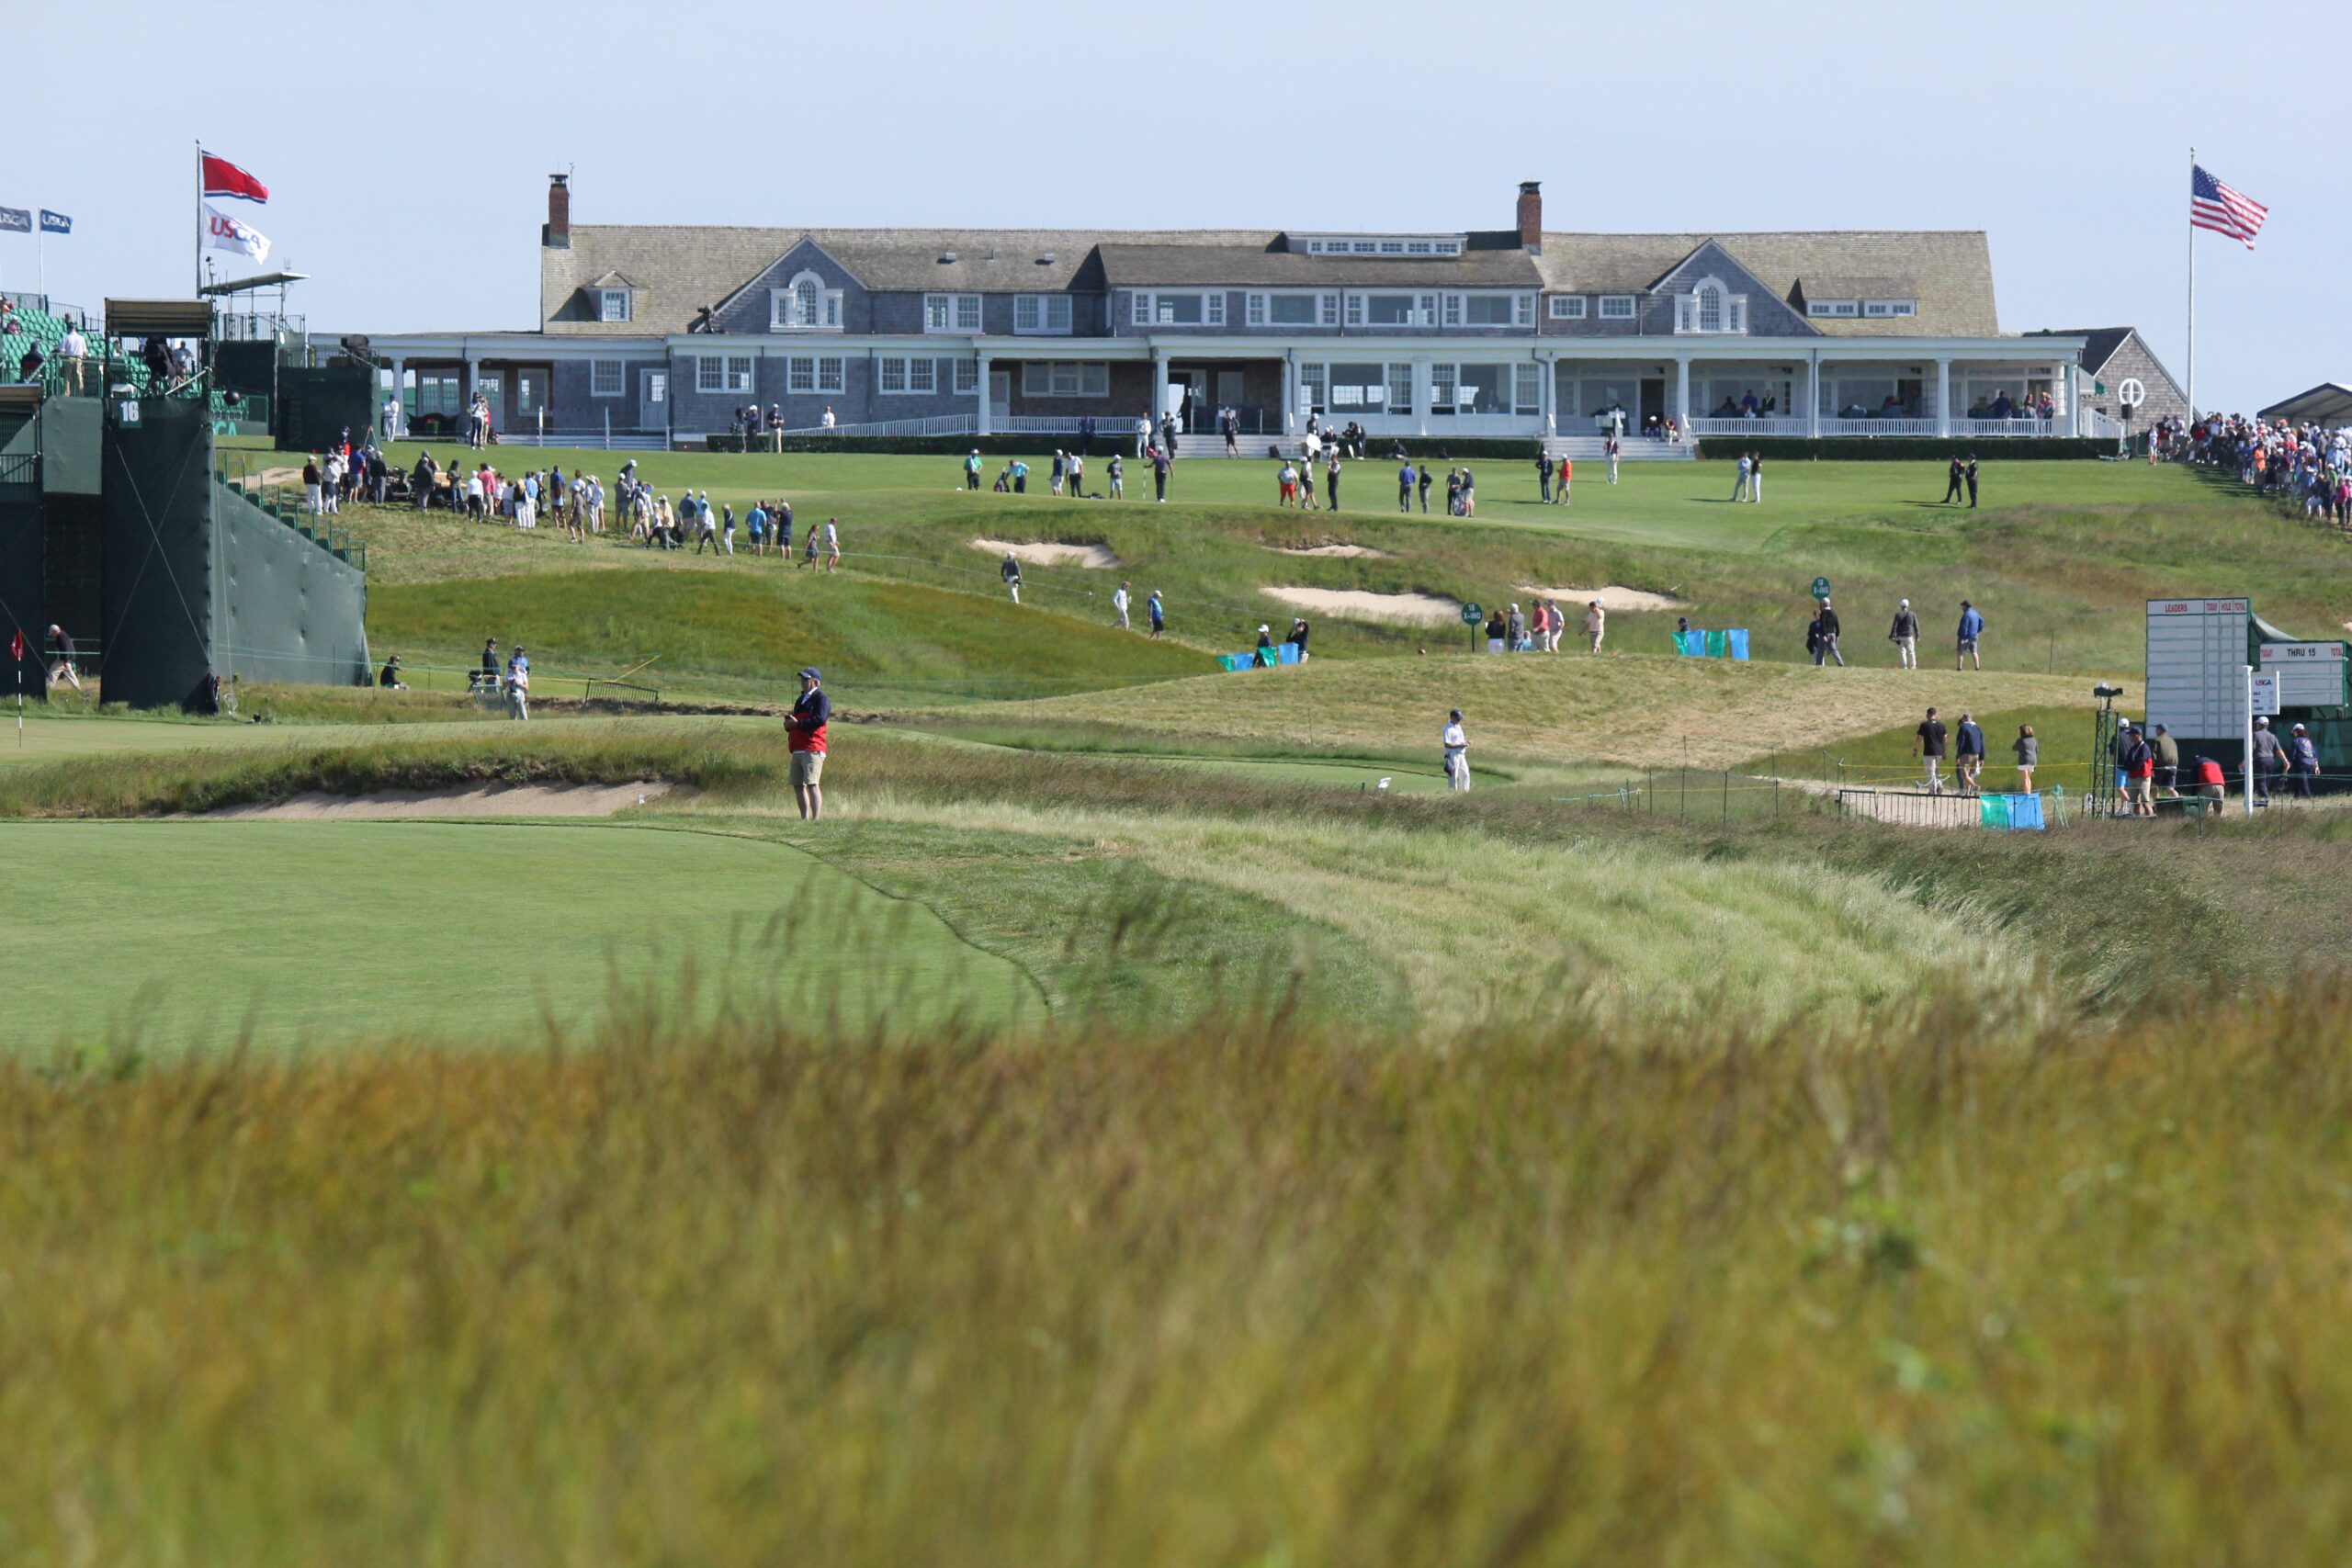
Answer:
[0,0,2352,412]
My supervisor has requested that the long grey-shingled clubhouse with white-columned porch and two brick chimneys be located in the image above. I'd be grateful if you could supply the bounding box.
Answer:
[371,176,2112,451]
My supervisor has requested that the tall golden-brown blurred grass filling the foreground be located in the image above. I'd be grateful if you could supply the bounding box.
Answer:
[0,987,2352,1568]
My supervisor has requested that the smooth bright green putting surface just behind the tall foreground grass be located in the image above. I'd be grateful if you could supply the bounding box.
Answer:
[0,820,1040,1048]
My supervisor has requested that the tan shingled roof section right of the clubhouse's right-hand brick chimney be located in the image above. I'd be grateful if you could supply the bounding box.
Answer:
[1536,231,2002,339]
